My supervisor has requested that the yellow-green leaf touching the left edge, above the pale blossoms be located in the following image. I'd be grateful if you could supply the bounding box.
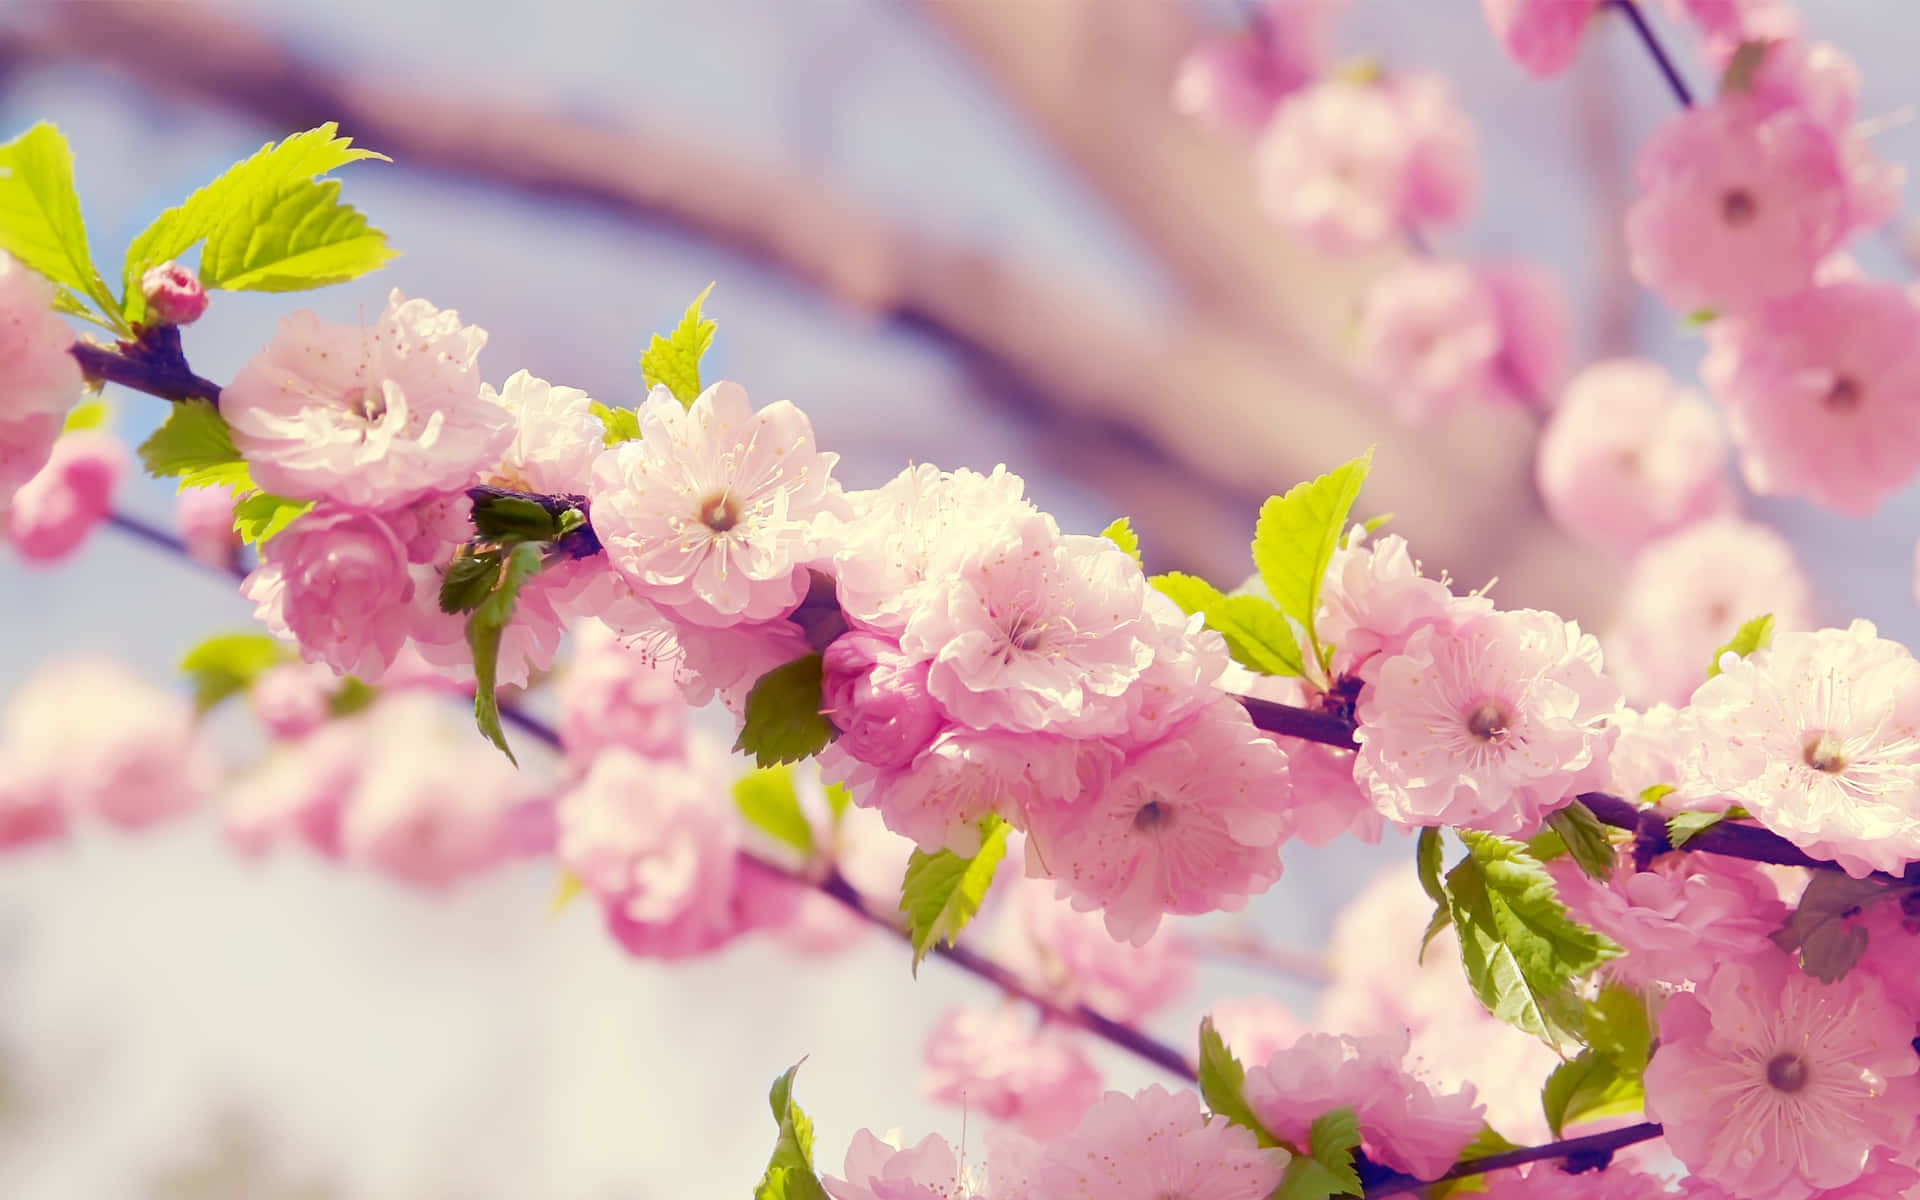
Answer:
[0,121,119,313]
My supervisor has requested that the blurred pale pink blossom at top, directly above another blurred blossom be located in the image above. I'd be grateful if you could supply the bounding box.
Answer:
[1254,77,1475,253]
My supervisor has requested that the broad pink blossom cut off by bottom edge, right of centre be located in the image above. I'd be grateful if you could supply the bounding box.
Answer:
[1031,1087,1288,1200]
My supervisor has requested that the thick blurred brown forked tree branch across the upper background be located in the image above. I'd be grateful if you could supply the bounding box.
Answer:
[0,0,1586,614]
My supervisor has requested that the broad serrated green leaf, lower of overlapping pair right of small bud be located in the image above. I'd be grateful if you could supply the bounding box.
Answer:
[200,179,396,292]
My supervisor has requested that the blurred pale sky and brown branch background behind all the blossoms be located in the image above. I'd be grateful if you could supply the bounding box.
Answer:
[0,0,1920,1200]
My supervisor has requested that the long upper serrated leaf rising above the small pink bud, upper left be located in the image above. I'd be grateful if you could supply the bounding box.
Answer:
[121,121,388,321]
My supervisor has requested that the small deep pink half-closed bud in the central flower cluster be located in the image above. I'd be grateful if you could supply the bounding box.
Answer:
[822,630,943,768]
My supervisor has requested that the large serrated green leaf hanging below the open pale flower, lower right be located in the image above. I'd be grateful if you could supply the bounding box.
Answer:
[1446,829,1622,1048]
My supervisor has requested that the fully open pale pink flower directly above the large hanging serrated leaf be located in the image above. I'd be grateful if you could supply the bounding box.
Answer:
[1354,611,1620,835]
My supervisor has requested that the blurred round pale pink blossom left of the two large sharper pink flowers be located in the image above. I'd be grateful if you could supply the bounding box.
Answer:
[1534,359,1734,555]
